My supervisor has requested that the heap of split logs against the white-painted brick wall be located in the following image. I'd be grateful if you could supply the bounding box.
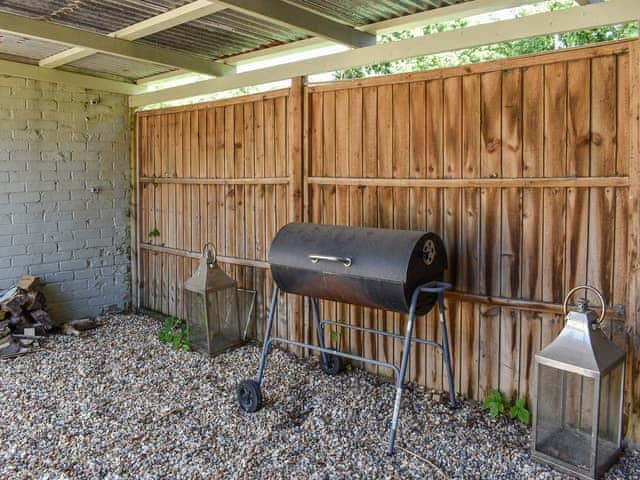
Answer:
[0,275,54,357]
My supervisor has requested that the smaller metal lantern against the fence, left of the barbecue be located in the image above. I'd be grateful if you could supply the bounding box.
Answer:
[184,243,243,355]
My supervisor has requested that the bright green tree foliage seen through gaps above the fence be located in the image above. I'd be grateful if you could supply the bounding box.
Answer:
[334,0,638,80]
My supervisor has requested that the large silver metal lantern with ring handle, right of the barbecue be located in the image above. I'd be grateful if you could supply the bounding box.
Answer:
[532,286,625,479]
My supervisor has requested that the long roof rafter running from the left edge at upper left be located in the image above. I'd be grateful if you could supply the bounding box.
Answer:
[0,13,234,76]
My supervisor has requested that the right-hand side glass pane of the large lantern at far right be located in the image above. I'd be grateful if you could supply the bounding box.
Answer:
[597,363,623,469]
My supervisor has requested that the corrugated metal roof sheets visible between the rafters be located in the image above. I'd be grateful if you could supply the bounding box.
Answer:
[0,0,470,80]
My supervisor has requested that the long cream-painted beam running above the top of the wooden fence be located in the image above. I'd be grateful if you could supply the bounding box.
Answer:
[129,0,640,107]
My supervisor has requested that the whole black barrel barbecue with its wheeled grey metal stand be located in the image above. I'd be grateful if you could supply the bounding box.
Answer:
[238,223,456,453]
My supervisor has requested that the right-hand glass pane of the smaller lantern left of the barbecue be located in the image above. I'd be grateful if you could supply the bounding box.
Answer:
[207,287,242,354]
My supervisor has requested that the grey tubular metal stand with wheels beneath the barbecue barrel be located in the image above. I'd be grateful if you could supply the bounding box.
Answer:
[238,281,457,455]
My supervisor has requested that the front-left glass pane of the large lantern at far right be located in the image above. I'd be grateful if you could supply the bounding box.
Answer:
[535,364,595,471]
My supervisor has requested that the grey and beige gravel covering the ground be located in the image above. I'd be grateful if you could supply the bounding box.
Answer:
[0,315,640,479]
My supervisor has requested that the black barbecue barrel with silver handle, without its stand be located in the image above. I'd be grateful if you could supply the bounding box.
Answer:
[269,223,447,315]
